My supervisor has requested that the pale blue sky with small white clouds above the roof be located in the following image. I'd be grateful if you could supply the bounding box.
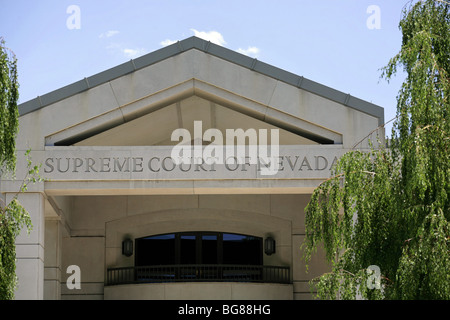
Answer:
[0,0,408,135]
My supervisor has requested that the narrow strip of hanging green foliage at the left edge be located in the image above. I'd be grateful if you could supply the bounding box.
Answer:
[0,38,40,300]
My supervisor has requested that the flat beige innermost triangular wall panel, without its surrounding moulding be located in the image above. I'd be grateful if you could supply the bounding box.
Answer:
[74,96,317,146]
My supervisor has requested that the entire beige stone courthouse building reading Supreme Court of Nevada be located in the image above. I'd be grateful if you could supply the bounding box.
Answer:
[0,37,384,300]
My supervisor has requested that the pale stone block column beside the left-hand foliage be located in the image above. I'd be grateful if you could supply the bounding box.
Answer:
[6,193,45,300]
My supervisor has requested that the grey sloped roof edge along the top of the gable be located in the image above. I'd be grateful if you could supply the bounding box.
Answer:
[18,37,384,125]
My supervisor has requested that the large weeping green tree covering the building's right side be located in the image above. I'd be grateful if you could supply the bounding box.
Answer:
[302,0,450,299]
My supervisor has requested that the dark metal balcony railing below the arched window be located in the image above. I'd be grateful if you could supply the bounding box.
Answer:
[106,264,290,286]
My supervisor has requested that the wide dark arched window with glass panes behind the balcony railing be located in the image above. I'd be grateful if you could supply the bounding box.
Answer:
[135,232,263,266]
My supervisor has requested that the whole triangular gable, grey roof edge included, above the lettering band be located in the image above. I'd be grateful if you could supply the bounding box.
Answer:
[19,37,384,146]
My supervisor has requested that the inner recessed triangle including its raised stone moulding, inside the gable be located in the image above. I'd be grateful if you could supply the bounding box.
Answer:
[46,79,342,146]
